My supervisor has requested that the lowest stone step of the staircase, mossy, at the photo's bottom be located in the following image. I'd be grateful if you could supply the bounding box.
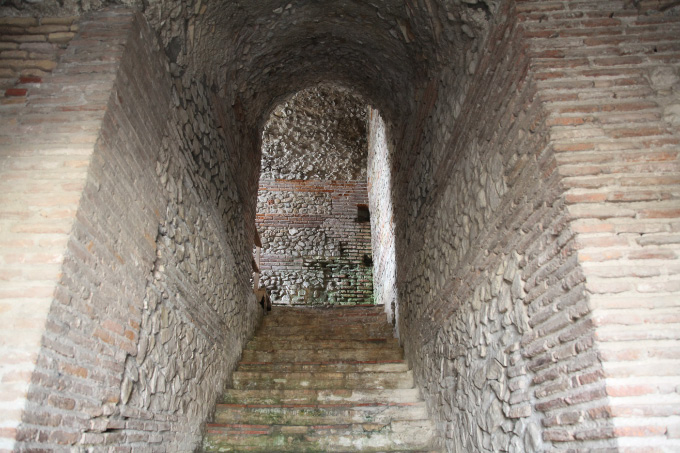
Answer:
[203,420,434,452]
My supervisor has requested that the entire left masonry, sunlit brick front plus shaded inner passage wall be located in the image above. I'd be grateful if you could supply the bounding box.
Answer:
[0,9,258,451]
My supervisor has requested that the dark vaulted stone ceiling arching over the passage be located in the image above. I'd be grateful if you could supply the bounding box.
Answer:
[0,0,502,124]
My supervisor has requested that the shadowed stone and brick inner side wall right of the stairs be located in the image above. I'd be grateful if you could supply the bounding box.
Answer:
[388,5,572,452]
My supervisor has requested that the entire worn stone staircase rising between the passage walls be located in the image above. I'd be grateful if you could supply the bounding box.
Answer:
[203,307,434,452]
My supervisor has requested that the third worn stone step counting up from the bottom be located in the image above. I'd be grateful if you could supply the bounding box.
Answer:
[220,388,420,405]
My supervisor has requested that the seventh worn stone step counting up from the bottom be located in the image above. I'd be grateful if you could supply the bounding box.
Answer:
[246,336,401,350]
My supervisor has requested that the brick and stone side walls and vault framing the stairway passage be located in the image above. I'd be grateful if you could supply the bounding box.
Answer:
[0,0,680,452]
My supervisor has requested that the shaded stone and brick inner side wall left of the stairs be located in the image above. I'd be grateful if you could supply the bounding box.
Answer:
[0,10,260,451]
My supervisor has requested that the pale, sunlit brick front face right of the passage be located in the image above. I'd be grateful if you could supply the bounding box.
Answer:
[519,1,680,451]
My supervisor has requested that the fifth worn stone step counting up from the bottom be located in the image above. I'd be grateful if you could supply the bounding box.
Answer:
[238,360,410,373]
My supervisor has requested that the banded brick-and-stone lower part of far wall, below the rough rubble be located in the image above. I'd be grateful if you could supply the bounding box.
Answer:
[257,179,373,304]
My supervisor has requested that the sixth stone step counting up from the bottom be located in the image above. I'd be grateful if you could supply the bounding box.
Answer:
[241,348,403,362]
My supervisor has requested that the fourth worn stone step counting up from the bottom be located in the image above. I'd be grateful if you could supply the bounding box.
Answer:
[232,371,414,389]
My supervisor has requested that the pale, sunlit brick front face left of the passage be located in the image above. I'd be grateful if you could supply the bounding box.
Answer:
[0,9,129,450]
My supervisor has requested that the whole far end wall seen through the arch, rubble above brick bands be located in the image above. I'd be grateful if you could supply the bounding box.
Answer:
[256,85,373,304]
